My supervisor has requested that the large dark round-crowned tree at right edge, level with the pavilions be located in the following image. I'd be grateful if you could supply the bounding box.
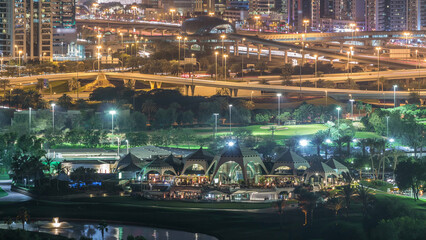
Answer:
[395,159,426,200]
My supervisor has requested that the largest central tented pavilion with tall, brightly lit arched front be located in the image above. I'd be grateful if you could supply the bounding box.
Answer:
[207,144,268,183]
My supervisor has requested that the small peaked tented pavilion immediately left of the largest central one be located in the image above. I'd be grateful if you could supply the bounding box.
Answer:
[182,147,213,175]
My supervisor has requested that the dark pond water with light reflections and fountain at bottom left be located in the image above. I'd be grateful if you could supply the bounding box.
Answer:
[0,221,217,240]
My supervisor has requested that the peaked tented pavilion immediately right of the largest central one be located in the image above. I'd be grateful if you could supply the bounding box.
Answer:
[270,150,310,175]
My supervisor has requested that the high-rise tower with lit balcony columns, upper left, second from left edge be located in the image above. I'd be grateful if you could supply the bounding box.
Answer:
[11,0,53,60]
